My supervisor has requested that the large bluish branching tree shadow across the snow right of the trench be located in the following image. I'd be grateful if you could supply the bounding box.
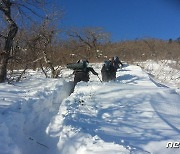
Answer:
[62,94,176,153]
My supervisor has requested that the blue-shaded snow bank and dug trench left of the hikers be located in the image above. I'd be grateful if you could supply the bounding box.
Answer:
[0,71,71,154]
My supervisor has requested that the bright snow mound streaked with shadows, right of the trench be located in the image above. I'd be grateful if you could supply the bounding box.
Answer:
[49,66,180,154]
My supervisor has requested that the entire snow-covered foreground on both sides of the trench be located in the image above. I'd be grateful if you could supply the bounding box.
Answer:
[0,64,180,154]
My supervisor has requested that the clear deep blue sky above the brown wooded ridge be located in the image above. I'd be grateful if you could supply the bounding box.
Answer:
[54,0,180,41]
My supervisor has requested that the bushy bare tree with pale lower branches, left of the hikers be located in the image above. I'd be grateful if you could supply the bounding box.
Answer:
[17,19,60,78]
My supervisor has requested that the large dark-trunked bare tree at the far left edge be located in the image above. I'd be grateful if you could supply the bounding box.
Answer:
[0,0,49,83]
